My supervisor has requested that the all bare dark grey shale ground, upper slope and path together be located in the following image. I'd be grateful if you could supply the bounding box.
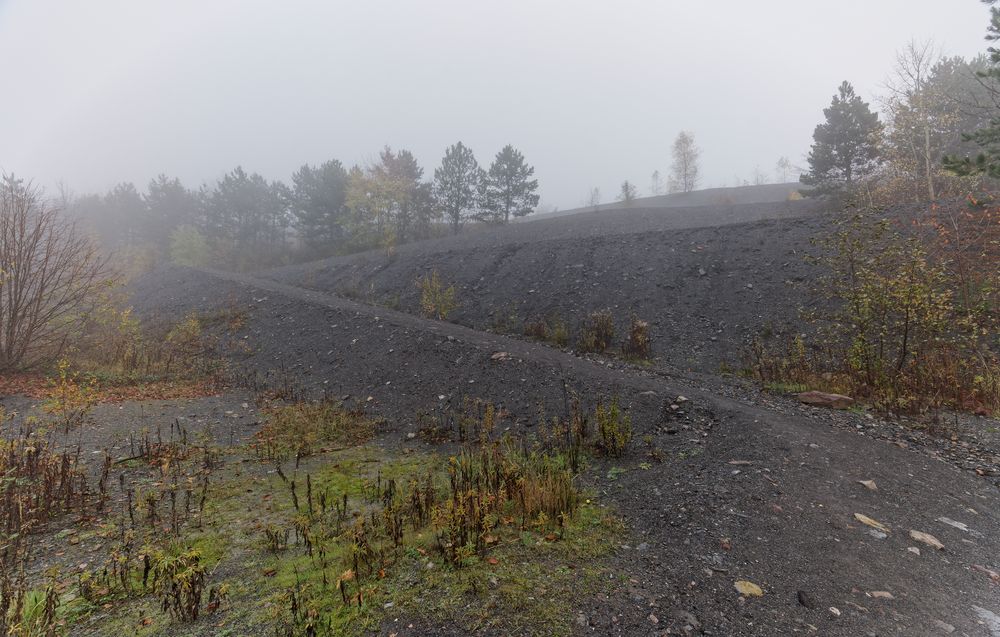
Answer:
[5,202,1000,637]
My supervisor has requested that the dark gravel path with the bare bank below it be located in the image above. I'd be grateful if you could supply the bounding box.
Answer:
[135,268,1000,637]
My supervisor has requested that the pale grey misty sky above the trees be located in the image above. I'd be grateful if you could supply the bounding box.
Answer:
[0,0,988,208]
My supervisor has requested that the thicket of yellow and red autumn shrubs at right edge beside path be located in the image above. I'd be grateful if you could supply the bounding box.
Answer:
[748,202,1000,413]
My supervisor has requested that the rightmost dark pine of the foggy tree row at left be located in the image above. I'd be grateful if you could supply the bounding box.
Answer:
[483,144,538,223]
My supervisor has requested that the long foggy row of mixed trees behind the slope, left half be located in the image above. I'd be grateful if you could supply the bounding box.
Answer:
[63,142,539,270]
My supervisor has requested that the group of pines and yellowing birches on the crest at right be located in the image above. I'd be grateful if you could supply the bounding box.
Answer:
[800,42,1000,205]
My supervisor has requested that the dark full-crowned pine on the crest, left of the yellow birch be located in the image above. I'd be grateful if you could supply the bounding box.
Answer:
[799,81,882,194]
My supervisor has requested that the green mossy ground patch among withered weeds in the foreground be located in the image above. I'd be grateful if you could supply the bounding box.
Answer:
[58,446,623,635]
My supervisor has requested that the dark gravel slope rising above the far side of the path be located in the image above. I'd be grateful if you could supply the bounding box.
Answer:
[261,202,831,372]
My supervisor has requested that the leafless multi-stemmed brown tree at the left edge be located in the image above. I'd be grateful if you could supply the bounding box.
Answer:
[0,175,108,370]
